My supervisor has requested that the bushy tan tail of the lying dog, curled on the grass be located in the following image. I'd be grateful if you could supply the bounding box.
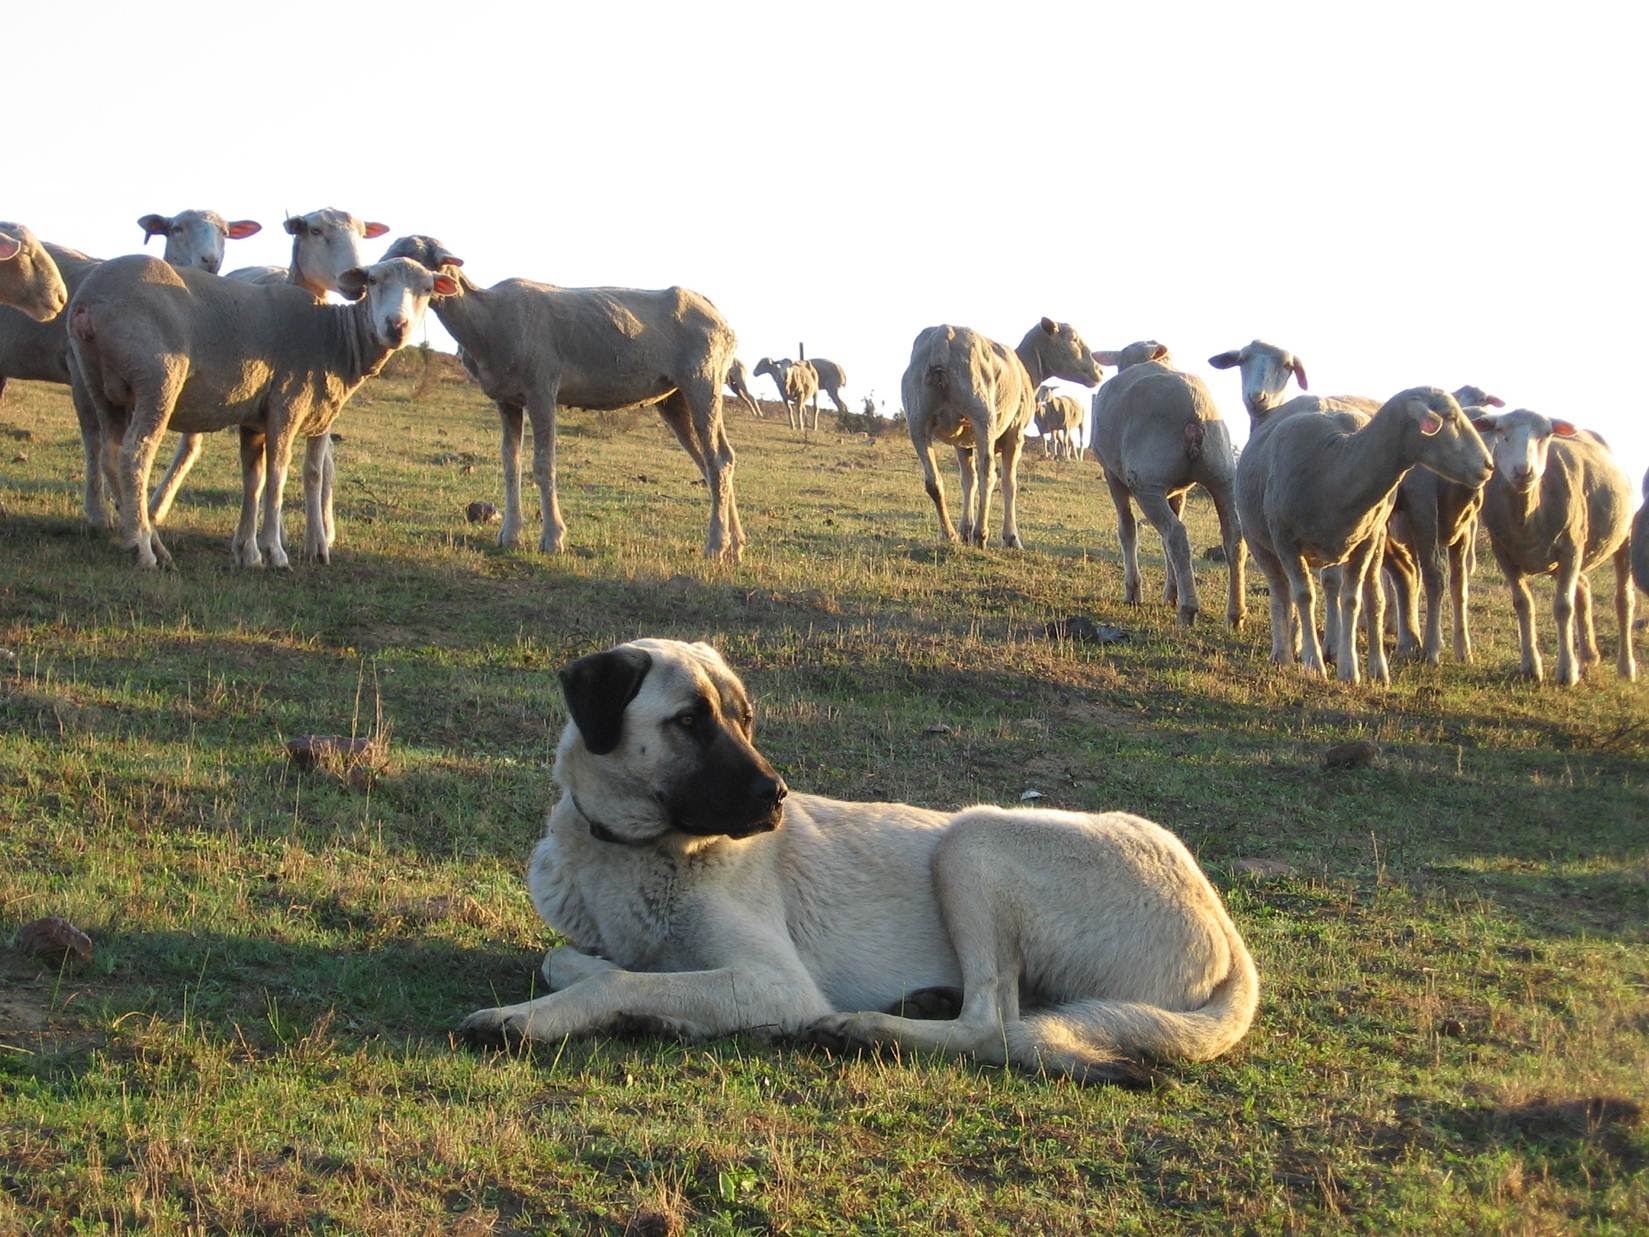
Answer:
[1008,915,1260,1085]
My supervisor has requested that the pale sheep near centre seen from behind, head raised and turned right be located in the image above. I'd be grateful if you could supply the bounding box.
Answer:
[900,318,1100,549]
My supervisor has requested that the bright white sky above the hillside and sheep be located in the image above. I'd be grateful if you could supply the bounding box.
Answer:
[16,0,1649,498]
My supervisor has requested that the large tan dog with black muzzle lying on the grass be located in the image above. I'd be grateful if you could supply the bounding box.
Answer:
[460,640,1258,1082]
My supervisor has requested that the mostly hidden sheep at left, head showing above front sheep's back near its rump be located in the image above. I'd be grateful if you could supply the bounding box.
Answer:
[0,211,257,528]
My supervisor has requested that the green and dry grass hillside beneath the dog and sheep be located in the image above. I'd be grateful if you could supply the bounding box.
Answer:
[0,371,1649,1234]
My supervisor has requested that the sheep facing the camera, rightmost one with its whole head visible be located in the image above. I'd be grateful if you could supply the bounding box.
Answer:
[1473,409,1637,686]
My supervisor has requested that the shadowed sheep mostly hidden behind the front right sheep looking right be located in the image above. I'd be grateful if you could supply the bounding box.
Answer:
[1385,386,1504,665]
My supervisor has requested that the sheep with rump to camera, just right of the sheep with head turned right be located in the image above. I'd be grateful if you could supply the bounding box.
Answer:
[1092,340,1247,627]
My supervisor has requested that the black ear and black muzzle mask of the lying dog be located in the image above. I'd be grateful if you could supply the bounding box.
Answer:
[561,648,788,838]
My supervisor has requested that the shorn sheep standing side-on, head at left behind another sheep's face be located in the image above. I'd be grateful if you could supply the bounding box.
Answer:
[388,236,745,562]
